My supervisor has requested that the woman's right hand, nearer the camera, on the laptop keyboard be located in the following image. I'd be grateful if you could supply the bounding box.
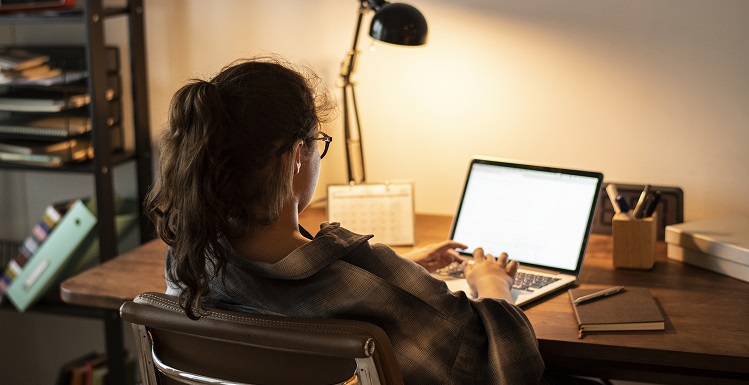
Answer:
[465,248,519,303]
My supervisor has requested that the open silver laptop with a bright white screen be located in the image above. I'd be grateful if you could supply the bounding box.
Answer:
[435,158,603,306]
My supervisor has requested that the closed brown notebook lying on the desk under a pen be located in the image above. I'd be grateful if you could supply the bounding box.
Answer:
[568,287,666,338]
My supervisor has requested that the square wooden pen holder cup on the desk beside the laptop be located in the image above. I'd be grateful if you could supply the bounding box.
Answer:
[611,213,658,270]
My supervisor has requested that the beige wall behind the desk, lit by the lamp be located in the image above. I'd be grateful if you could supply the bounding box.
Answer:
[146,0,749,219]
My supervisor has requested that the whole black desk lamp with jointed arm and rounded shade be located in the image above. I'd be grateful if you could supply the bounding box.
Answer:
[340,0,427,183]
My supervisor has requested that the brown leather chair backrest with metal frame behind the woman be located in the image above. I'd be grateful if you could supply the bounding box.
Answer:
[120,293,403,385]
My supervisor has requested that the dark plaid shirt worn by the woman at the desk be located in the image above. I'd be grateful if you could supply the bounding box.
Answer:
[167,223,544,385]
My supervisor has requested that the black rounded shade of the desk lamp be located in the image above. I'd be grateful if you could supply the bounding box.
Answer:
[369,3,428,45]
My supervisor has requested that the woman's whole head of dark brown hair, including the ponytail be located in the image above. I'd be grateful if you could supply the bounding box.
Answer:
[145,57,331,318]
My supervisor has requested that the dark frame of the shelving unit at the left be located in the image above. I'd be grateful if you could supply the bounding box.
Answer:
[0,0,153,384]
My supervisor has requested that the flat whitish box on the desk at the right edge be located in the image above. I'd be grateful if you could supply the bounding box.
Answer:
[666,216,749,282]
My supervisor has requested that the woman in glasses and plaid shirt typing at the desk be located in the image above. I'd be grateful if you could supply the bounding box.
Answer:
[146,58,543,384]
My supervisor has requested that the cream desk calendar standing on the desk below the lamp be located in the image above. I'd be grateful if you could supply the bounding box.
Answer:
[328,182,414,246]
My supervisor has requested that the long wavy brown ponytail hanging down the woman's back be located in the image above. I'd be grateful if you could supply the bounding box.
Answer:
[146,80,240,318]
